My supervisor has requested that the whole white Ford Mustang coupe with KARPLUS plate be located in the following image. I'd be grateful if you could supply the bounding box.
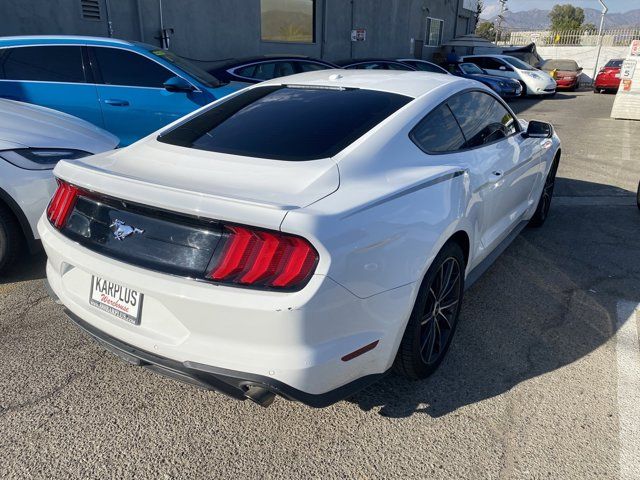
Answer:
[39,70,560,407]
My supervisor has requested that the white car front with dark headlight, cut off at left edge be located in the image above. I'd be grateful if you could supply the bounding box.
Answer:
[0,99,118,271]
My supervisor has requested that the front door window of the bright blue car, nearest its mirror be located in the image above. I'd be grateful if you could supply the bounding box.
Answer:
[93,47,175,88]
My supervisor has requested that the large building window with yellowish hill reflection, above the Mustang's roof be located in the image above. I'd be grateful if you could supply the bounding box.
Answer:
[260,0,316,43]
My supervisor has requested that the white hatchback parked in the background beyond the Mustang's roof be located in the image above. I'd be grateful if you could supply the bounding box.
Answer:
[462,55,557,96]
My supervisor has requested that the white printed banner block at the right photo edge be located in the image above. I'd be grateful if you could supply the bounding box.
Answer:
[611,40,640,120]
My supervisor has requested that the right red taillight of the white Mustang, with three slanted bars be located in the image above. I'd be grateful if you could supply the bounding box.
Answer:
[207,226,318,289]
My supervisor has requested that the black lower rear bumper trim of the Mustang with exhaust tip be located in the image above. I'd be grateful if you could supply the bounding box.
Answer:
[65,310,386,408]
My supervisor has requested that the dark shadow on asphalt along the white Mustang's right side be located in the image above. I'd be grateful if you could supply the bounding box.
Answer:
[348,179,640,417]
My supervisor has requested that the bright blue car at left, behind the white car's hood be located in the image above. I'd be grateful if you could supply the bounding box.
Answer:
[0,36,239,146]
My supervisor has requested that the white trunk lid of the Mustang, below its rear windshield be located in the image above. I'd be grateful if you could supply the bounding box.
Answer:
[55,139,339,229]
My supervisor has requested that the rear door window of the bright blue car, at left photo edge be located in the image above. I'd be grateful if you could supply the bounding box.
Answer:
[0,46,85,83]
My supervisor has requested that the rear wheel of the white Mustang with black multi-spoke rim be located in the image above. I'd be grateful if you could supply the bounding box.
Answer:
[393,242,465,380]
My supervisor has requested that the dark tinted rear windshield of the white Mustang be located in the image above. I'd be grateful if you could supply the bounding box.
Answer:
[158,86,412,161]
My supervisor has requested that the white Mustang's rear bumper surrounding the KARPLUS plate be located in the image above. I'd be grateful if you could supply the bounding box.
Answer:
[38,218,415,406]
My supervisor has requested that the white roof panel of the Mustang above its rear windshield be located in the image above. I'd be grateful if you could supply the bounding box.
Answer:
[253,69,478,98]
